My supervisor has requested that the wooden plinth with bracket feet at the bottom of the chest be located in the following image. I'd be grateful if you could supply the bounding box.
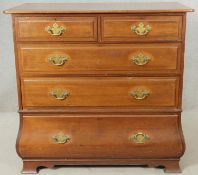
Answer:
[22,159,181,174]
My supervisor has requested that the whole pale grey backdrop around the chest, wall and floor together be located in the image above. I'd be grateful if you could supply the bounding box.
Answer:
[0,0,198,175]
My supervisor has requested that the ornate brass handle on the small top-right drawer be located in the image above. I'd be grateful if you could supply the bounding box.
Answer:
[131,22,152,36]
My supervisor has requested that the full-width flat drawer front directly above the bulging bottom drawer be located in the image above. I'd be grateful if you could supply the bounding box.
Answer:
[22,77,179,108]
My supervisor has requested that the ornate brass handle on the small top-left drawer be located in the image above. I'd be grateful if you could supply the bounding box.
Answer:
[45,23,66,36]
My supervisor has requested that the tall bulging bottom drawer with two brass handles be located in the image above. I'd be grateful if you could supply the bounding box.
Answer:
[18,115,184,159]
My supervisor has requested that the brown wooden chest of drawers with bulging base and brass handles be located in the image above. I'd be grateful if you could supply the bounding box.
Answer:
[5,3,192,173]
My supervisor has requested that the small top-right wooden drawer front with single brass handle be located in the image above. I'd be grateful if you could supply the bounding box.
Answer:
[102,16,182,41]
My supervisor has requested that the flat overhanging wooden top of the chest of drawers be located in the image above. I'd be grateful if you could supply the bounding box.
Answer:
[4,2,193,14]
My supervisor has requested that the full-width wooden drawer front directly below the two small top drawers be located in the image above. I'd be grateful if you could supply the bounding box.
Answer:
[18,43,181,74]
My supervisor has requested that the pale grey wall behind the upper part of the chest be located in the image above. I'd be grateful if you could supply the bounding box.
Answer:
[0,0,198,112]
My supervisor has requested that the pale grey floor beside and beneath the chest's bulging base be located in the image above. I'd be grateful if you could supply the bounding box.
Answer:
[0,111,198,175]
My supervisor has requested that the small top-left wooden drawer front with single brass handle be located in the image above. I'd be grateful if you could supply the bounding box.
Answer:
[15,16,97,41]
